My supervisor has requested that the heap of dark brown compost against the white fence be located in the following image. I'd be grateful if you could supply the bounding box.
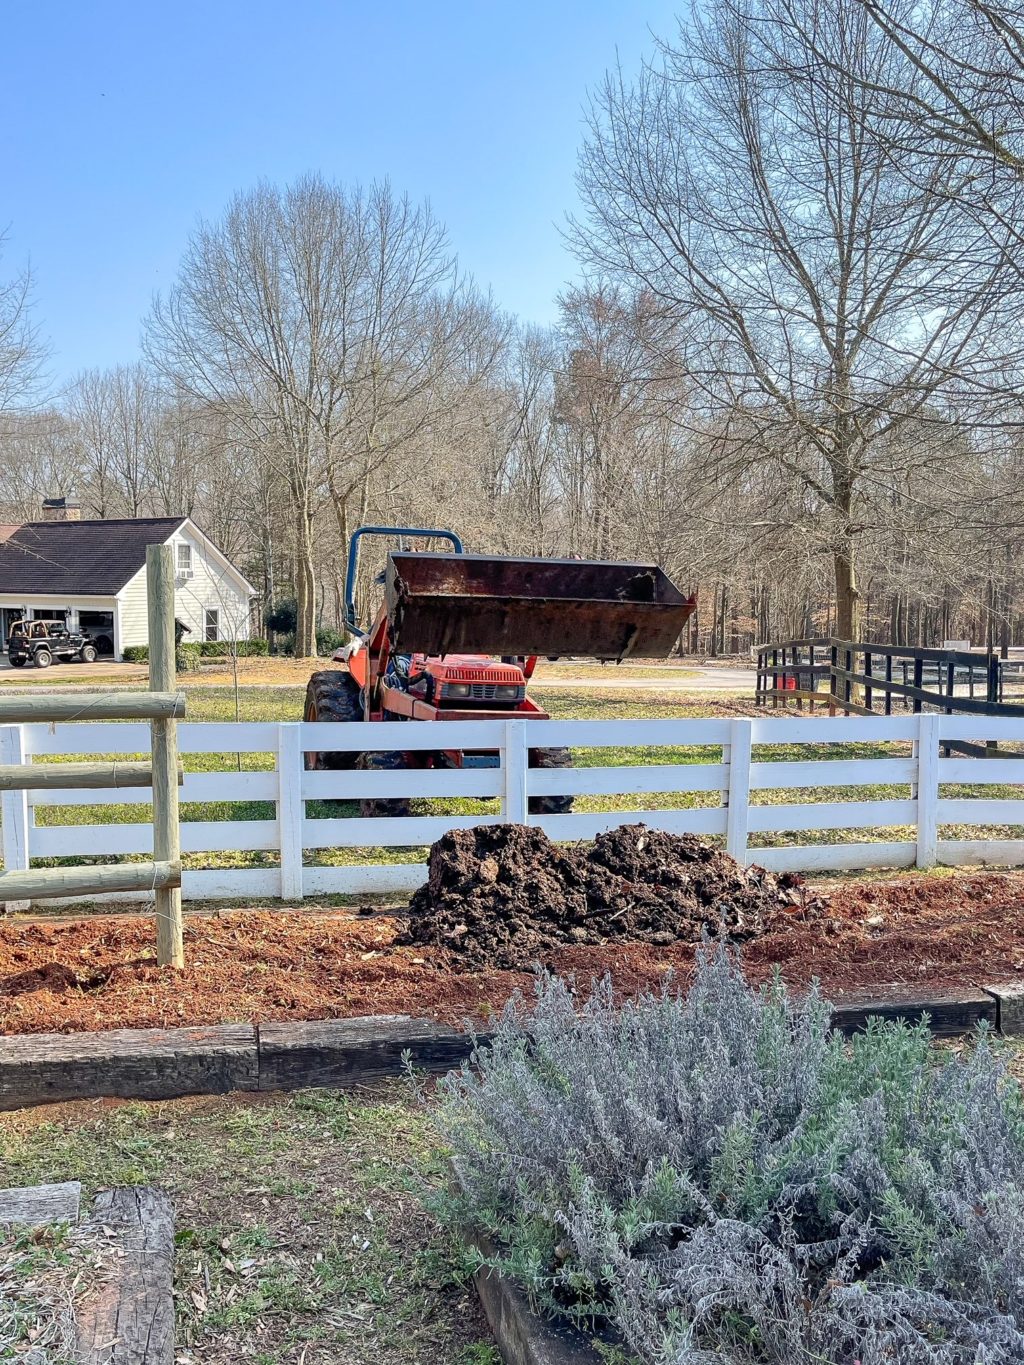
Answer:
[399,824,822,971]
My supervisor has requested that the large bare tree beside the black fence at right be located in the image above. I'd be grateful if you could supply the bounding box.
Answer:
[575,0,1020,637]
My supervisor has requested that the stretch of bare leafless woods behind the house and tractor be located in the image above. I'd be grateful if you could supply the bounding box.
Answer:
[0,0,1024,654]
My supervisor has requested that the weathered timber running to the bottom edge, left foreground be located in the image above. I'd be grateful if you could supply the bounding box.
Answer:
[75,1185,175,1365]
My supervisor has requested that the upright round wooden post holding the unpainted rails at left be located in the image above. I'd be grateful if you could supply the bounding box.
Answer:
[146,545,184,966]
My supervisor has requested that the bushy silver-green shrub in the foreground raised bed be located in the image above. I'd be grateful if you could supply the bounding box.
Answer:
[436,953,1024,1365]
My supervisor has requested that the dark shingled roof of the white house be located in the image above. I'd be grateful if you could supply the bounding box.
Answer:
[0,516,187,597]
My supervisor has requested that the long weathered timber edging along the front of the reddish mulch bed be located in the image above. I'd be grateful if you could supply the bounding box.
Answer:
[0,986,1004,1110]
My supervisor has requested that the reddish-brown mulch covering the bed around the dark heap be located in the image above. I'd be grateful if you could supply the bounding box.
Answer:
[0,872,1024,1033]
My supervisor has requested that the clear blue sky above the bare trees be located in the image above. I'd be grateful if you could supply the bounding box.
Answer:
[0,0,680,379]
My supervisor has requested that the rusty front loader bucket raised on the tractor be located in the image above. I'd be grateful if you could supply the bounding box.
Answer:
[385,551,696,659]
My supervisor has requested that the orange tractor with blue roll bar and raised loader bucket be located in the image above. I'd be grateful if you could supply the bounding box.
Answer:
[304,526,696,815]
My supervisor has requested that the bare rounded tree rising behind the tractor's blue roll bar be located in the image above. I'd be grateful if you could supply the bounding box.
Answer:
[146,176,494,655]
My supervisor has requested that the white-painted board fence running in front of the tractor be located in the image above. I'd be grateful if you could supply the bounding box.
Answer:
[0,714,1024,902]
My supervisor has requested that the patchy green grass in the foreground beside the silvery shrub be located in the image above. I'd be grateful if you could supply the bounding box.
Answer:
[0,1085,498,1365]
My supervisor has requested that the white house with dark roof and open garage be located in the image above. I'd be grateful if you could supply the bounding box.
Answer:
[0,510,254,659]
